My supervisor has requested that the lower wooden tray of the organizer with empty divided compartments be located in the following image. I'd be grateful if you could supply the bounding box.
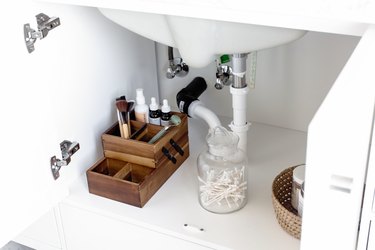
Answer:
[86,139,189,207]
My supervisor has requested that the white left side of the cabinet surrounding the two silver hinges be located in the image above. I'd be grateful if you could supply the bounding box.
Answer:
[0,0,157,247]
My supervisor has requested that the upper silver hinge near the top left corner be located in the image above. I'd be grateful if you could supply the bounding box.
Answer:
[23,13,60,53]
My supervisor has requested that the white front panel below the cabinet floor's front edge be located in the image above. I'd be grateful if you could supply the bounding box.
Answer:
[60,204,211,250]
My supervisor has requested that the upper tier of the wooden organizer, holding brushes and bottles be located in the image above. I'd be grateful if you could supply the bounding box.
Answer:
[102,112,188,168]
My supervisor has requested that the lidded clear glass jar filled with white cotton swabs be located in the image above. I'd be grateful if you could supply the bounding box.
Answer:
[197,126,247,213]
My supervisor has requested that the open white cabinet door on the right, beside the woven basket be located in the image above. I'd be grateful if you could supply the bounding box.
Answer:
[301,26,375,250]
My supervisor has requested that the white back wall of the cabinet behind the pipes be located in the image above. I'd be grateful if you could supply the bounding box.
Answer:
[157,32,359,131]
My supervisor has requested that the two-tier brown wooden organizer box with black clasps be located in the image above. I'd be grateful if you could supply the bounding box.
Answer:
[86,113,189,207]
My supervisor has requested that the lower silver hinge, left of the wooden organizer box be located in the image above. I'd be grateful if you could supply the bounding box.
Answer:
[51,140,80,180]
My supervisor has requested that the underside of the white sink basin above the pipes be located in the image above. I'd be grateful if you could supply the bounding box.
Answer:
[99,8,306,67]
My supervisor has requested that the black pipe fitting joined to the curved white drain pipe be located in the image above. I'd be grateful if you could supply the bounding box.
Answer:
[176,76,207,114]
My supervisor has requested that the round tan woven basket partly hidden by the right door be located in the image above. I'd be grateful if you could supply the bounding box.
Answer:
[272,166,302,239]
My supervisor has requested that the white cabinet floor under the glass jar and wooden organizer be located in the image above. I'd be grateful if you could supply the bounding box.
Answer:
[62,117,306,250]
